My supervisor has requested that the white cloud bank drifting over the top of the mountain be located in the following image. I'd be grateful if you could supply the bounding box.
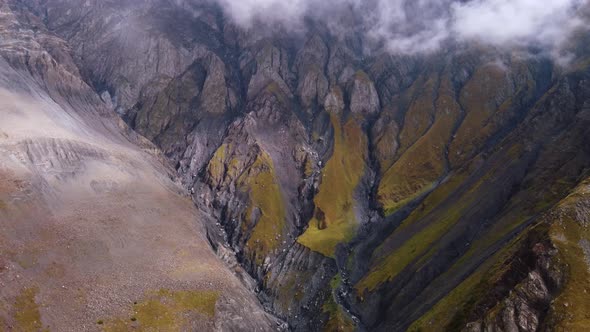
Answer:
[216,0,588,54]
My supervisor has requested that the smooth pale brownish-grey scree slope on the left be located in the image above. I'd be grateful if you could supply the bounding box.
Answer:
[0,2,281,331]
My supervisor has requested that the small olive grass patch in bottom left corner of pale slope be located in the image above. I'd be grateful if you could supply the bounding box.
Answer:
[14,287,43,332]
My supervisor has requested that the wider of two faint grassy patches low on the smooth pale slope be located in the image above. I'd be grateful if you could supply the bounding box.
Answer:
[103,289,219,332]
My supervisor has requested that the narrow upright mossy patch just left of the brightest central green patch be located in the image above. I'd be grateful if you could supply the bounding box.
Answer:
[238,151,285,263]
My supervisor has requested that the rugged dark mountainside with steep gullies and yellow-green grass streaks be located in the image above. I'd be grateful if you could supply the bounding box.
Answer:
[5,0,590,331]
